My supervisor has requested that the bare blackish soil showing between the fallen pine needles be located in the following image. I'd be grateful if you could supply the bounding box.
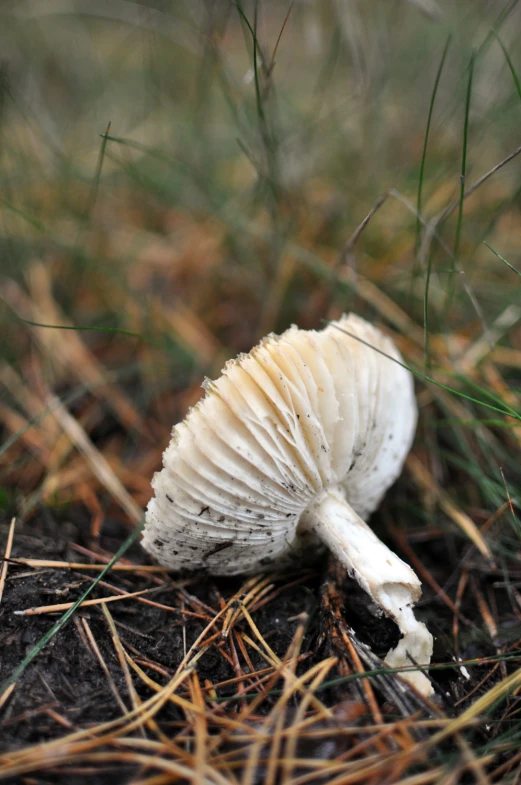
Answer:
[0,510,519,785]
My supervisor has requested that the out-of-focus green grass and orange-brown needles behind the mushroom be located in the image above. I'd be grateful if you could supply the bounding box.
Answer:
[0,0,521,533]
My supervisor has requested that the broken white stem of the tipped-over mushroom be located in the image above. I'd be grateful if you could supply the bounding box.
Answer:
[301,486,433,696]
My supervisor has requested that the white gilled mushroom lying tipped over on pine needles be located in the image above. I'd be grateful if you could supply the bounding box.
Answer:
[143,314,433,695]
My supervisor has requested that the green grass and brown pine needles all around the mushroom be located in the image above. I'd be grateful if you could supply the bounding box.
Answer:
[0,0,521,785]
